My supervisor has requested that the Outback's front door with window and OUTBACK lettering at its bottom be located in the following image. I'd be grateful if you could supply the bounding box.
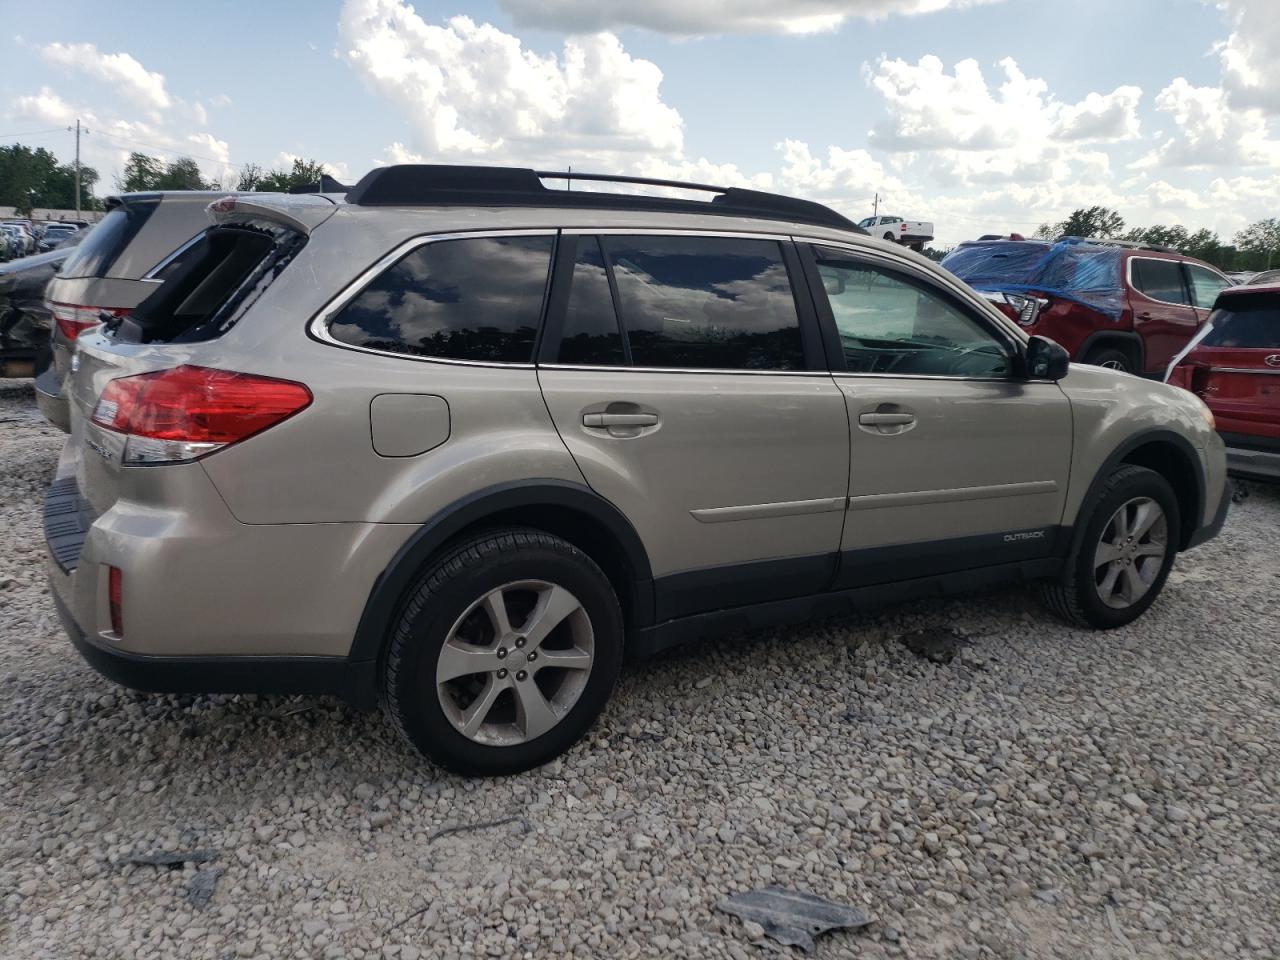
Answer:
[804,244,1071,588]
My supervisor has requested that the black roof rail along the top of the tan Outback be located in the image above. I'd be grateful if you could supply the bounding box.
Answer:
[347,164,867,233]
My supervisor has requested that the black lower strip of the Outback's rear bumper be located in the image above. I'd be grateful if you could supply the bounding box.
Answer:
[51,590,378,709]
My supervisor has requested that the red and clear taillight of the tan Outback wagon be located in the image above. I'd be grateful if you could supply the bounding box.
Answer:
[93,366,311,463]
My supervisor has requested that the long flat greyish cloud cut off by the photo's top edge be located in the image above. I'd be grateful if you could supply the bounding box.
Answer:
[499,0,997,36]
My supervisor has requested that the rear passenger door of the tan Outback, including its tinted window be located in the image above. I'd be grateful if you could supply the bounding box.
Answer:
[538,232,849,621]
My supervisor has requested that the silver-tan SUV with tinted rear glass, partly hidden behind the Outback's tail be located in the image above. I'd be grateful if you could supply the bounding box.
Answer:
[36,191,238,430]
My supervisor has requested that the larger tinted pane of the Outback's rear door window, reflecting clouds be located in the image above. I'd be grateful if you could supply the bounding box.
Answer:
[603,237,804,370]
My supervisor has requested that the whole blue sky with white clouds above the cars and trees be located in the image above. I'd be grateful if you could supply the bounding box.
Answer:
[0,0,1280,246]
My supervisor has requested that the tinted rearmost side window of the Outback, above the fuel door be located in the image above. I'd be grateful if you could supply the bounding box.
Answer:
[329,237,553,364]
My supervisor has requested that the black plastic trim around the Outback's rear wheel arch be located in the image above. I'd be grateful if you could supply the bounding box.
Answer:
[348,479,653,662]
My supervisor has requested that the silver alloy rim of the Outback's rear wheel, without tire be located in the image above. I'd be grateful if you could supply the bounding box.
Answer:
[435,580,595,746]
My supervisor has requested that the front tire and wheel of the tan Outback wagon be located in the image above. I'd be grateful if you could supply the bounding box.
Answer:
[1044,466,1180,630]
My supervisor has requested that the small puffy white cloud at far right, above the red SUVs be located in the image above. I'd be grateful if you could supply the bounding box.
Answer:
[1135,77,1280,169]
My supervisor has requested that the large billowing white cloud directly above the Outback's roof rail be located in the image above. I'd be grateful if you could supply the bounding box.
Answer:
[338,0,684,164]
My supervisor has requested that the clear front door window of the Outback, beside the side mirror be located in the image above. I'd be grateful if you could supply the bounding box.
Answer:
[818,255,1009,376]
